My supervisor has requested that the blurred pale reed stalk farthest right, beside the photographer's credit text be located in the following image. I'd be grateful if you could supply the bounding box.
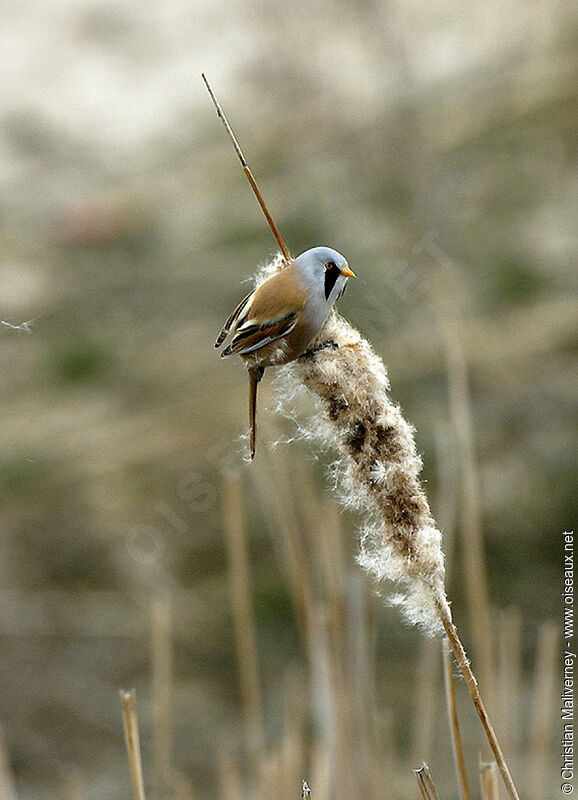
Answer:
[526,621,560,797]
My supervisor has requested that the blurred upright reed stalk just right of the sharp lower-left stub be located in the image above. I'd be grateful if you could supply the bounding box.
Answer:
[151,596,174,800]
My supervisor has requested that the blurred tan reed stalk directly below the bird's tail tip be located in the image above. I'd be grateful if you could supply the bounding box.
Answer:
[224,475,265,770]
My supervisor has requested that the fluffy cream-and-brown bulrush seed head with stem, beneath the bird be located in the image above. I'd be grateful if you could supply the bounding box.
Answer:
[263,258,518,800]
